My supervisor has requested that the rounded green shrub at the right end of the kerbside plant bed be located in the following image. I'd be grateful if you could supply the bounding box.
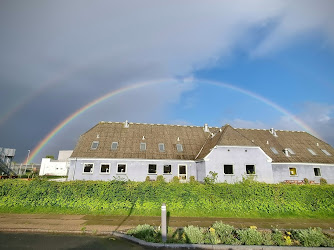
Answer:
[292,227,326,247]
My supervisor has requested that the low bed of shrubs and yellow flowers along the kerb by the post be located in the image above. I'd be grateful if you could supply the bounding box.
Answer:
[127,222,334,247]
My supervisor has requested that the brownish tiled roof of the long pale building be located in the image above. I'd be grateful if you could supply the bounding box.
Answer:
[71,122,334,163]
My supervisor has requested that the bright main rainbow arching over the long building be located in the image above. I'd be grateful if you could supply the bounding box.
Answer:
[24,79,319,164]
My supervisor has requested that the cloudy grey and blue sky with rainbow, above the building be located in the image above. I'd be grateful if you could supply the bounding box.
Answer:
[0,0,334,163]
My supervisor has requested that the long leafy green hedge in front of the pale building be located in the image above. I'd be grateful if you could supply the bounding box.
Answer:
[0,180,334,218]
